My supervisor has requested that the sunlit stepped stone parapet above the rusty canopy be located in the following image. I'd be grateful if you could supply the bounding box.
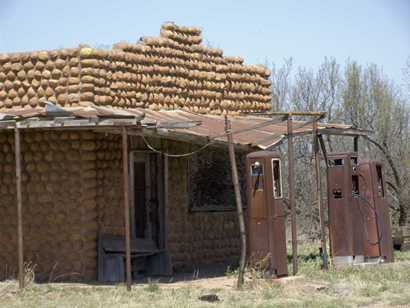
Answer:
[0,24,271,114]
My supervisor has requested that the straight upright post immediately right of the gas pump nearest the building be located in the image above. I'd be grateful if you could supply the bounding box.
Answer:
[287,116,298,275]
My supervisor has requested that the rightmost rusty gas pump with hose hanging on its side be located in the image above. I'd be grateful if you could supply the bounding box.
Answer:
[359,160,393,262]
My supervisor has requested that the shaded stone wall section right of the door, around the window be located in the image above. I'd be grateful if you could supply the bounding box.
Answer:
[167,141,240,270]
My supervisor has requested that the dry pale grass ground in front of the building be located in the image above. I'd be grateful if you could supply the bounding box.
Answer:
[0,248,410,308]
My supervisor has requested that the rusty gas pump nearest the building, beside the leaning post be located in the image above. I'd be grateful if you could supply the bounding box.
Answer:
[246,151,288,277]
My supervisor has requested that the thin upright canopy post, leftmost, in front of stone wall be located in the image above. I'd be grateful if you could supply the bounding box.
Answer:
[14,126,24,289]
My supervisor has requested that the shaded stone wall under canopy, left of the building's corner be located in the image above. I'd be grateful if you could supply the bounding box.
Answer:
[0,131,97,280]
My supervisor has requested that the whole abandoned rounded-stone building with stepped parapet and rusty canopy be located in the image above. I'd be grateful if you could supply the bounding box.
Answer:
[0,24,362,281]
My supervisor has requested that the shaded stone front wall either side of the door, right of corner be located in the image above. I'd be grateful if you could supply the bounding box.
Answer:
[92,135,240,271]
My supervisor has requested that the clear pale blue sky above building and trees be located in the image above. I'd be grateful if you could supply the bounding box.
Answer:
[0,0,410,84]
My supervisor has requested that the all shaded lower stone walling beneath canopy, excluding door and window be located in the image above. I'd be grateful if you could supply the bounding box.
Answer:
[0,131,239,281]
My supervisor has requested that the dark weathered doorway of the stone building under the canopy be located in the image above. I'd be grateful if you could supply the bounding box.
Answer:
[129,151,170,275]
